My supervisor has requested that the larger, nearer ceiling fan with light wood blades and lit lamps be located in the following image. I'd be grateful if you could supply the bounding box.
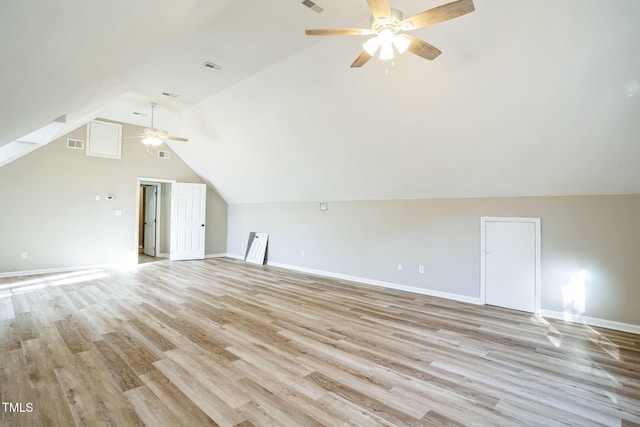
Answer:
[305,0,475,68]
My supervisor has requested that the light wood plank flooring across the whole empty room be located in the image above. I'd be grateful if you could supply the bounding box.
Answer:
[0,259,640,427]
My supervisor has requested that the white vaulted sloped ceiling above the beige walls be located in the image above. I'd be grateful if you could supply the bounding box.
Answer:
[0,0,640,203]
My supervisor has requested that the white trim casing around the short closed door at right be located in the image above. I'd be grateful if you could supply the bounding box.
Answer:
[480,216,542,315]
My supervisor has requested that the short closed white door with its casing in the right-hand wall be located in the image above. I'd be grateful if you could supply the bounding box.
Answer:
[482,218,540,313]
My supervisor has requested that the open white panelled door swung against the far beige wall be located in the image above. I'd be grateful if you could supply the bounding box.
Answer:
[169,182,207,261]
